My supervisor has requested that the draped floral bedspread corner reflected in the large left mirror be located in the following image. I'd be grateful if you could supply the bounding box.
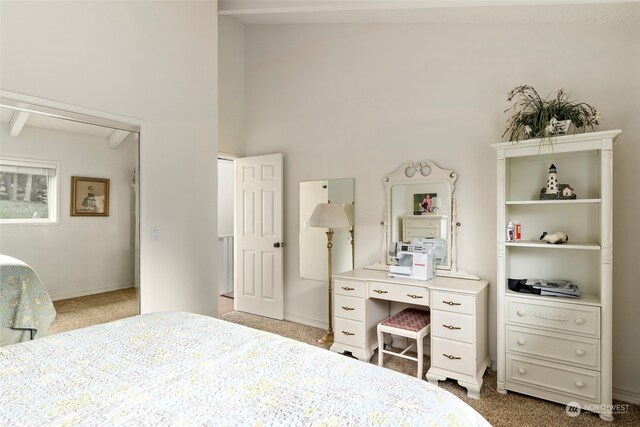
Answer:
[0,255,56,339]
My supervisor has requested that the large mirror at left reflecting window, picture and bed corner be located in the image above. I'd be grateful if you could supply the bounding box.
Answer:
[0,98,140,346]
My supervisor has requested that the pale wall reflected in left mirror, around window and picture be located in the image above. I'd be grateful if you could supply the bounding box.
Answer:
[0,123,138,300]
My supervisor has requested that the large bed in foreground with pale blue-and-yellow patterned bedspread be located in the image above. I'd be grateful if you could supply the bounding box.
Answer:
[0,313,488,426]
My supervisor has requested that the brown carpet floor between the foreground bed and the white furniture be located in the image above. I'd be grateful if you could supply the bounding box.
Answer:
[220,311,640,427]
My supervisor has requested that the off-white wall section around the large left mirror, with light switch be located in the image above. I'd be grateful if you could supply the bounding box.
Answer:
[0,1,218,315]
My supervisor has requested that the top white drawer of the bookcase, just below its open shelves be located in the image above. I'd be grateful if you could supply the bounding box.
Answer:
[507,297,600,338]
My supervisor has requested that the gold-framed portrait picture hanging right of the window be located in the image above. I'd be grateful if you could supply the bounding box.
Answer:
[71,176,109,216]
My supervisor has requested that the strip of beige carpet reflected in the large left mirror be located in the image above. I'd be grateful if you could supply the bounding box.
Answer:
[48,288,139,335]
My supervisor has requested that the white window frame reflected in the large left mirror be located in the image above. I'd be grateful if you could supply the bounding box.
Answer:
[0,156,61,225]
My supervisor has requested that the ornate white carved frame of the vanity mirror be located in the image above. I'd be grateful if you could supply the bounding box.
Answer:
[383,160,479,280]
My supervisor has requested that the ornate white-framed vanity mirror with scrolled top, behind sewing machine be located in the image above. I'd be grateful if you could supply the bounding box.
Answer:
[384,160,476,278]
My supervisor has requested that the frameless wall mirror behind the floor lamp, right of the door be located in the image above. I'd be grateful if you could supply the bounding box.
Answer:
[299,178,355,281]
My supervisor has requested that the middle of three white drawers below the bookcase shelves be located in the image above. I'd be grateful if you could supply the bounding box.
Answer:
[504,328,600,369]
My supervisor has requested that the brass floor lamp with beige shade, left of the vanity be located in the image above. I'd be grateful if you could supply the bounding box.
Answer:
[309,203,350,344]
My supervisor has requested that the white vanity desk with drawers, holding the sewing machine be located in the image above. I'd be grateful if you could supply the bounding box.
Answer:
[331,268,490,399]
